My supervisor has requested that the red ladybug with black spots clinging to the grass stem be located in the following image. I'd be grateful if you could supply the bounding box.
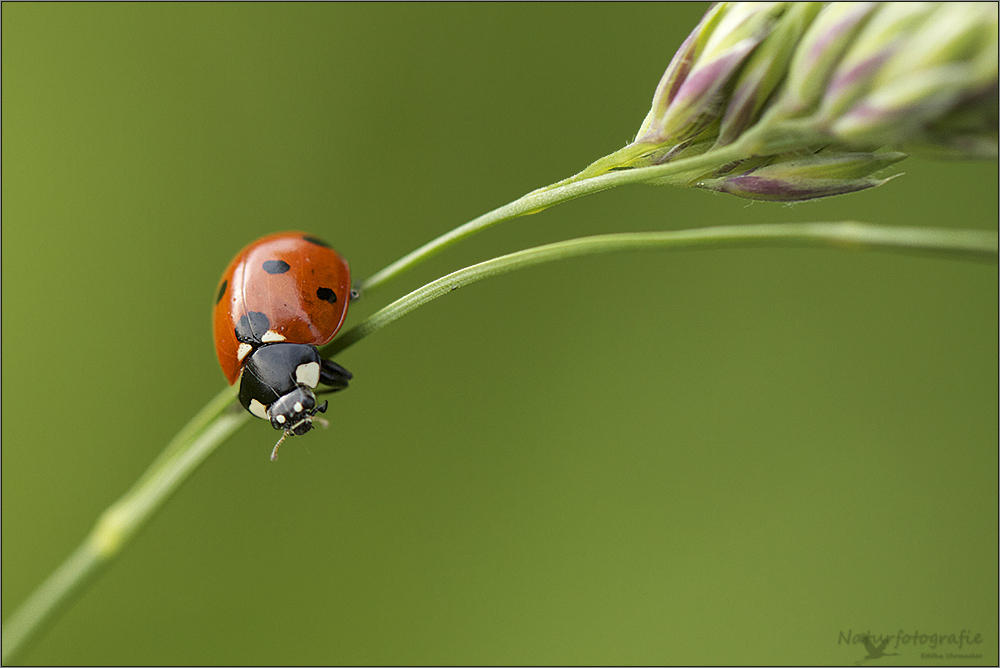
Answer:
[212,232,352,461]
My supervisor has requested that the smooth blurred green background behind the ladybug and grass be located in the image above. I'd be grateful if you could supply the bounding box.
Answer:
[2,3,998,665]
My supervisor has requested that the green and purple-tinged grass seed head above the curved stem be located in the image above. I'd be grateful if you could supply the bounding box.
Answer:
[574,2,1000,201]
